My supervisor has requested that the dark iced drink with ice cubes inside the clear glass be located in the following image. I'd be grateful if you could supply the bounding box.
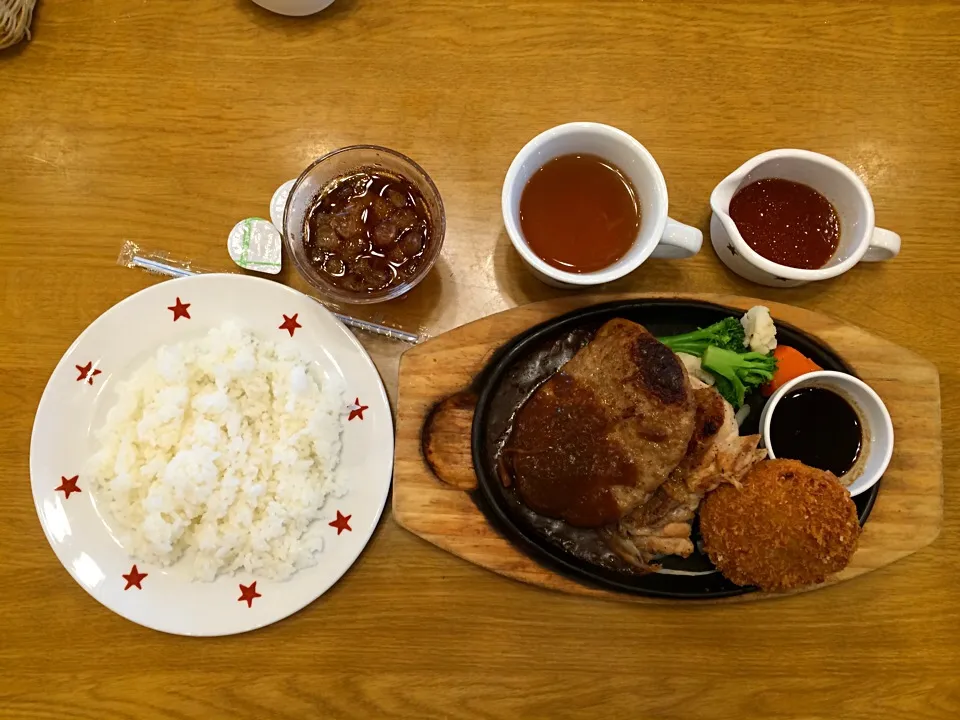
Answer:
[303,168,433,294]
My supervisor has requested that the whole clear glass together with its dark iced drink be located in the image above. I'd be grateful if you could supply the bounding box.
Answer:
[283,145,445,304]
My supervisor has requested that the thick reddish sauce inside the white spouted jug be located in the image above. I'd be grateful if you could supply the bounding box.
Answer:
[730,178,840,270]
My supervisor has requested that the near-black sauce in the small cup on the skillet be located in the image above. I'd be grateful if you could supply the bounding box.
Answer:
[770,387,863,477]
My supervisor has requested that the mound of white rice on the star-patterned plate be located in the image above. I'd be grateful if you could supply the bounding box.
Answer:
[88,324,346,581]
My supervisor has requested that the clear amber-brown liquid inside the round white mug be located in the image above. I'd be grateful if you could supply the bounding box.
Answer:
[520,155,640,273]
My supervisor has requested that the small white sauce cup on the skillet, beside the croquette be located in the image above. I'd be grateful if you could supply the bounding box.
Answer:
[760,370,893,496]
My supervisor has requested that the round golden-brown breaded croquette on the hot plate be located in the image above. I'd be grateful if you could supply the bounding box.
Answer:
[700,460,860,591]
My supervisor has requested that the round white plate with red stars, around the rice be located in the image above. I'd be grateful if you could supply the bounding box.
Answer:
[30,275,393,635]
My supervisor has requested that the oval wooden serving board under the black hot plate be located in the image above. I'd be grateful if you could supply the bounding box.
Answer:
[393,294,943,603]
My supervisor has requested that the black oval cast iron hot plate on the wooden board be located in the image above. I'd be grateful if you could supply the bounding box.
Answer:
[472,300,880,599]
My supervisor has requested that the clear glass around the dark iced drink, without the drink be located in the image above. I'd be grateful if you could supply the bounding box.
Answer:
[283,145,446,305]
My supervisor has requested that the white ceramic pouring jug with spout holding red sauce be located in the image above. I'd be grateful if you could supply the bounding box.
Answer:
[710,150,900,287]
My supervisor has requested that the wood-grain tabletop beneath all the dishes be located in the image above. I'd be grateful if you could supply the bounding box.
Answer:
[0,0,960,720]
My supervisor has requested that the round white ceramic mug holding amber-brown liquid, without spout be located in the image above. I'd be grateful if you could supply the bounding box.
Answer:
[500,122,703,287]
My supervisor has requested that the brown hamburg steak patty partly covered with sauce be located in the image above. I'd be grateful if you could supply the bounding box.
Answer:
[500,318,696,527]
